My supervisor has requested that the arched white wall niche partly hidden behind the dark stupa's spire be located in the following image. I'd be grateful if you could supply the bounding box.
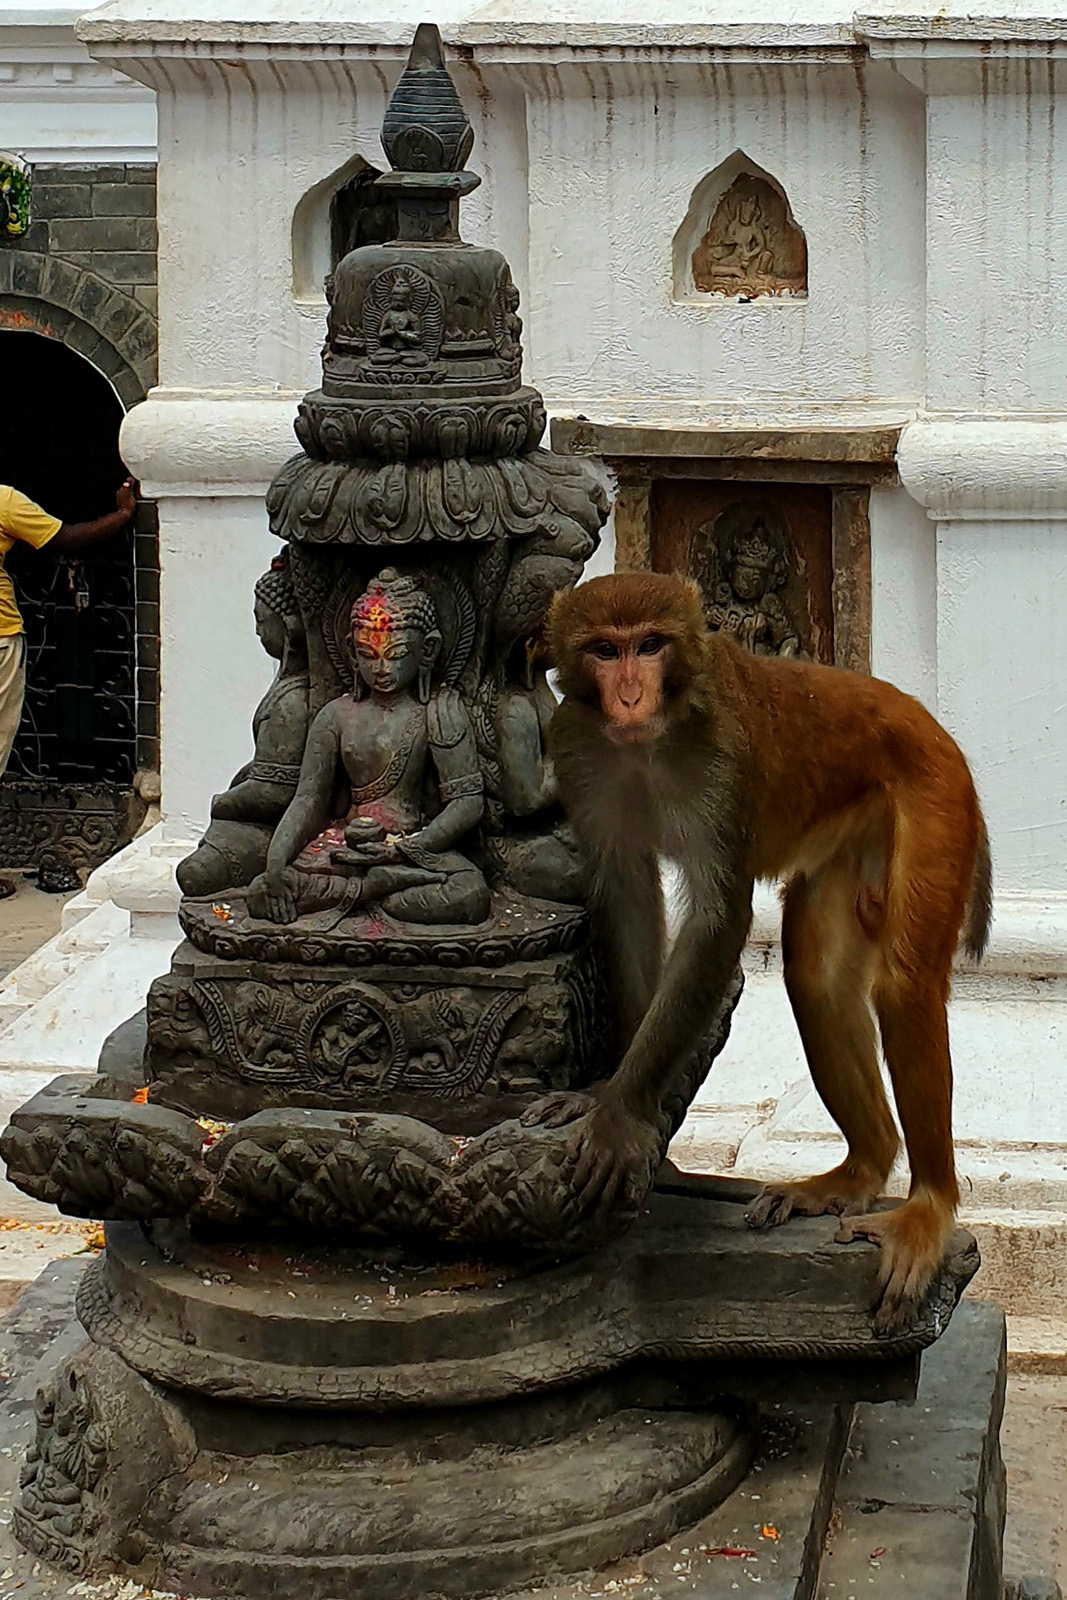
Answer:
[293,155,397,306]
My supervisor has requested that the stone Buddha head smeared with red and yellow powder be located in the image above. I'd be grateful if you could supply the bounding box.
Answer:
[352,566,442,702]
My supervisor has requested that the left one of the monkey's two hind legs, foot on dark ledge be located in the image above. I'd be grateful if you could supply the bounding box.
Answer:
[745,853,899,1227]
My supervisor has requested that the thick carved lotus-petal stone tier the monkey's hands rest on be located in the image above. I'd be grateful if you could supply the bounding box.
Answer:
[0,974,741,1261]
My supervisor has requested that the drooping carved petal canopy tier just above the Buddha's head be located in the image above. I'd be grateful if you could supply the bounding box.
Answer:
[267,450,608,547]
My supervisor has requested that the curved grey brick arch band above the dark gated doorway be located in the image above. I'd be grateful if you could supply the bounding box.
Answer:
[0,250,158,411]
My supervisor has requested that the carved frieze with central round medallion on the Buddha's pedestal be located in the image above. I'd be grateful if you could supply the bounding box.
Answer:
[149,946,606,1110]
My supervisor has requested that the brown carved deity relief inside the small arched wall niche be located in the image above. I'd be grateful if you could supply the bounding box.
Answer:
[693,173,808,296]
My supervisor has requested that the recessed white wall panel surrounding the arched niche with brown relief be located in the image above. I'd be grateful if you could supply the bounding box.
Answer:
[528,61,925,419]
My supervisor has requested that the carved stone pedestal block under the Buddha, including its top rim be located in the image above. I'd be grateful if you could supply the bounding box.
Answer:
[147,896,613,1131]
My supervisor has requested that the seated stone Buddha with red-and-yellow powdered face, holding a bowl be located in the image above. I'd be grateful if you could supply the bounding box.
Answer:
[248,568,490,923]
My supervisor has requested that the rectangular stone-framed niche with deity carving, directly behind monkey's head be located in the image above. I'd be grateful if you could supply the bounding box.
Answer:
[552,418,899,672]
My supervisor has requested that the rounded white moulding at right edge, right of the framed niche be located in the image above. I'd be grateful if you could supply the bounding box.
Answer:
[897,416,1067,522]
